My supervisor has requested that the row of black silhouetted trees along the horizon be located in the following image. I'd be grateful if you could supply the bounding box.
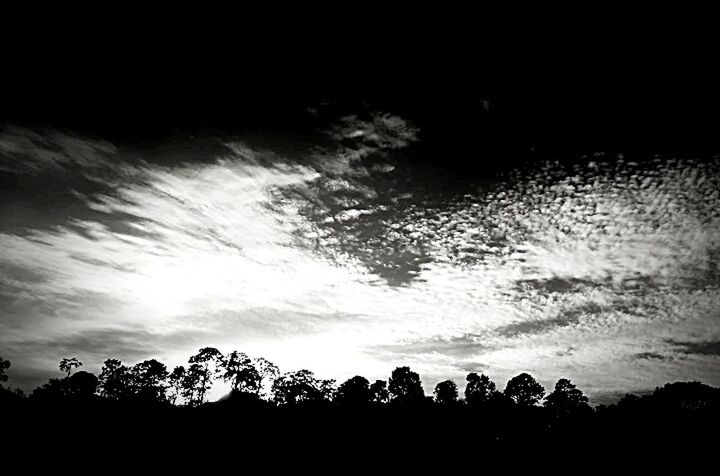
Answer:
[0,347,720,418]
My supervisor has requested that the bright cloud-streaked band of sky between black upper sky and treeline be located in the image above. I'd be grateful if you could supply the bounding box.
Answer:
[0,110,720,403]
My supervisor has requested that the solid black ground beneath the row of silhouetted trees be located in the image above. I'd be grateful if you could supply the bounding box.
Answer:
[0,389,720,468]
